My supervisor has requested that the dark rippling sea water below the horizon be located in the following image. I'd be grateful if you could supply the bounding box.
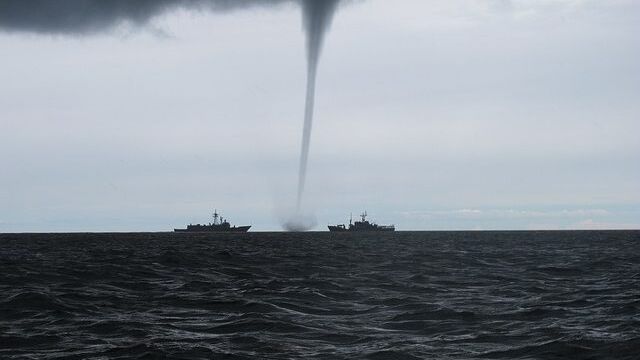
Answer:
[0,231,640,359]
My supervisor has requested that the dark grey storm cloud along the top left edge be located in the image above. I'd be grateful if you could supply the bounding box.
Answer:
[0,0,296,35]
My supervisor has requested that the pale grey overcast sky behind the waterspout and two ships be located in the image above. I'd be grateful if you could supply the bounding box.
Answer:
[0,0,640,232]
